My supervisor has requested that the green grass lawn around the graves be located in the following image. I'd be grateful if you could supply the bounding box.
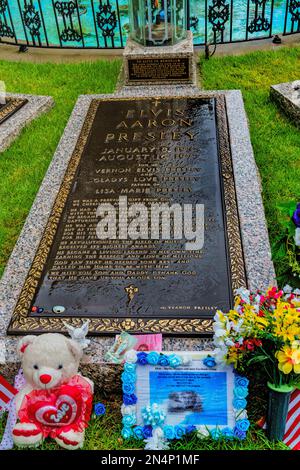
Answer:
[0,48,300,450]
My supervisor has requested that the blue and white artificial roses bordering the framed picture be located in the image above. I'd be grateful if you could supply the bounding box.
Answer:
[121,350,250,450]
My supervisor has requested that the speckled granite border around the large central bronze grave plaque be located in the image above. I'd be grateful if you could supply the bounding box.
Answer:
[0,86,276,389]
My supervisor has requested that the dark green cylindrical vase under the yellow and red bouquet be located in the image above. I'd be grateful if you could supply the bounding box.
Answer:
[267,382,294,441]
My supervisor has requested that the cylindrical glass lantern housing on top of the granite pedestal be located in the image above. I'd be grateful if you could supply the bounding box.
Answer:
[129,0,187,46]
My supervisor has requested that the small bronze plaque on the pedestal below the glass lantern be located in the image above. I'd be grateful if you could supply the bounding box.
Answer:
[128,57,190,82]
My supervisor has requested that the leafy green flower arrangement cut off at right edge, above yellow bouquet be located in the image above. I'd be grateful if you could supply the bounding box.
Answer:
[273,201,300,286]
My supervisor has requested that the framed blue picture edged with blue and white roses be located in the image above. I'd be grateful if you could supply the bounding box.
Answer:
[122,351,249,439]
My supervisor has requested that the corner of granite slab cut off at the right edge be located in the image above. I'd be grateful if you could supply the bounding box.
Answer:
[270,80,300,128]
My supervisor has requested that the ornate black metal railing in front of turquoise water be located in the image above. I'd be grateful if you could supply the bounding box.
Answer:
[0,0,300,49]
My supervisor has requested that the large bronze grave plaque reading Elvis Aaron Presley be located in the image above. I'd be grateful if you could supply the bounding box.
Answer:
[8,96,246,335]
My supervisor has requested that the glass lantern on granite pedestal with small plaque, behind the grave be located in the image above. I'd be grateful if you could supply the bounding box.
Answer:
[124,0,194,85]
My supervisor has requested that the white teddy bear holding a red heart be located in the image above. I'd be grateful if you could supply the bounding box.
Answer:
[13,333,93,449]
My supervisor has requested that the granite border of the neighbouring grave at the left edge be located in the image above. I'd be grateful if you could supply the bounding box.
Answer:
[0,93,54,152]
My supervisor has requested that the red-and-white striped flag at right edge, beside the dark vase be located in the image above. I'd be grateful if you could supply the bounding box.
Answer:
[283,390,300,450]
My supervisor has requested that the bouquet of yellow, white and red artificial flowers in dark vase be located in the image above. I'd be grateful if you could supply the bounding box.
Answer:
[214,286,300,388]
